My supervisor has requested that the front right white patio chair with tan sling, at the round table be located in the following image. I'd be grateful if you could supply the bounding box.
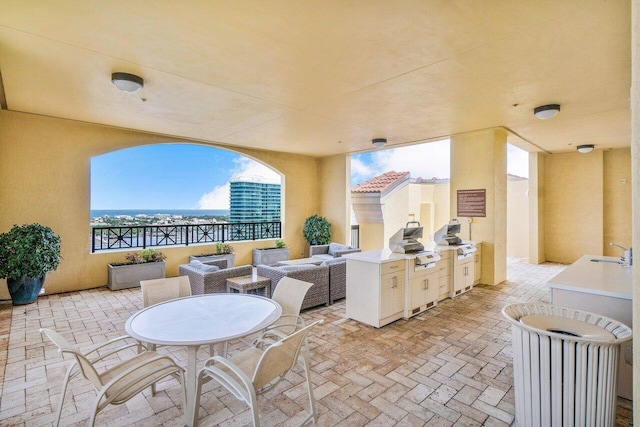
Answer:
[193,320,322,427]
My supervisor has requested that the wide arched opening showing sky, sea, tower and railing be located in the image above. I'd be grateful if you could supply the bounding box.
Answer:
[90,143,283,252]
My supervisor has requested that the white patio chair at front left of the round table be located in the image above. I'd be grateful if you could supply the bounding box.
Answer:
[40,328,186,426]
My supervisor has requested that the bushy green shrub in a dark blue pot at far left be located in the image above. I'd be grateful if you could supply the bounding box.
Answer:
[0,223,61,305]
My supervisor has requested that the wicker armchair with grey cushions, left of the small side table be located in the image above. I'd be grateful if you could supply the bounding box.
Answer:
[178,260,253,295]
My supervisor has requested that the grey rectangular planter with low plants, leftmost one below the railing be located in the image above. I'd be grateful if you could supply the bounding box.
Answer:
[108,249,166,291]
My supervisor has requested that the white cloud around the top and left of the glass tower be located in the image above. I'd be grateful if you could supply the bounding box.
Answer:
[198,157,281,209]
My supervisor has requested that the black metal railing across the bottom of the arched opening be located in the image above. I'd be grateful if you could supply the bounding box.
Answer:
[91,221,282,252]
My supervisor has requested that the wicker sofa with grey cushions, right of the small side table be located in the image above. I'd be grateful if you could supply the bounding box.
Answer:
[257,264,329,309]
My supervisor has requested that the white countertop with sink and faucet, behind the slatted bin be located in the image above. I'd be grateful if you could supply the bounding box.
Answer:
[547,255,633,300]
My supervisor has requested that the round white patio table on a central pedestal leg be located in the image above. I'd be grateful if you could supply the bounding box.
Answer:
[124,294,282,426]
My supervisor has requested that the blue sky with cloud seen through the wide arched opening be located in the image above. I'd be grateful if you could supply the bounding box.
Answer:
[91,144,279,209]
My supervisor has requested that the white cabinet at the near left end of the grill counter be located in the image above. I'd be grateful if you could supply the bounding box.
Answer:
[345,251,405,328]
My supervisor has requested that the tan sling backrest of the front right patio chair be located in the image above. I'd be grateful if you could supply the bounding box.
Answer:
[251,320,322,390]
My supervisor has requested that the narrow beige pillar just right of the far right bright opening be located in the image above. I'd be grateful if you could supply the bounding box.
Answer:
[529,153,546,264]
